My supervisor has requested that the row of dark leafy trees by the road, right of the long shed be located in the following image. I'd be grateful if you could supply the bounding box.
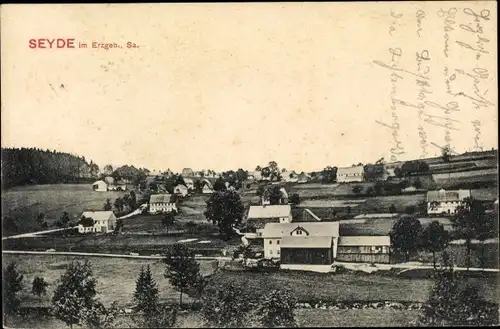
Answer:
[389,198,498,268]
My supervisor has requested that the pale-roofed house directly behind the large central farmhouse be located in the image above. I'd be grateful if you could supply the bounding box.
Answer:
[247,204,292,235]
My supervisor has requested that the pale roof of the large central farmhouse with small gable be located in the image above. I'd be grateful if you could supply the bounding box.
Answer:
[262,222,339,238]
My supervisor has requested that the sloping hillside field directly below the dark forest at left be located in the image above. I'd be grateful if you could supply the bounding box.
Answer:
[2,184,126,234]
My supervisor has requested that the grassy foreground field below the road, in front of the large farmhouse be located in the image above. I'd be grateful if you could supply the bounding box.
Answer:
[206,271,498,302]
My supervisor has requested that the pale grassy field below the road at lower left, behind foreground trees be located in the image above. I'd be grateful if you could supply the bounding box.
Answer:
[2,254,218,307]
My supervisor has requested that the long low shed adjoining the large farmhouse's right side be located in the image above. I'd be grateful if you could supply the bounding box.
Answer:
[336,236,391,264]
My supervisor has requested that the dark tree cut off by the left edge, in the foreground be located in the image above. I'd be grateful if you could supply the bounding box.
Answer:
[2,262,24,315]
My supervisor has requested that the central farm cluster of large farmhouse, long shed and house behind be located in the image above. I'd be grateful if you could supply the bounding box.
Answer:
[244,204,391,272]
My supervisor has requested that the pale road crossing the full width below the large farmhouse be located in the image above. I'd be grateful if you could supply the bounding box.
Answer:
[2,250,499,272]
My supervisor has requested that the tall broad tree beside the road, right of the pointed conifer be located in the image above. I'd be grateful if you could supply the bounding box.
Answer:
[164,244,203,306]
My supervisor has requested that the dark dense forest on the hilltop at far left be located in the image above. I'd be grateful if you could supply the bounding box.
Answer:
[2,148,99,190]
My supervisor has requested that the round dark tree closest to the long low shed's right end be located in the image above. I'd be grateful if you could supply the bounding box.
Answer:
[389,216,422,262]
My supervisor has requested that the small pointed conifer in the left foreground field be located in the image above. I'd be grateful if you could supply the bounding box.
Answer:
[134,265,159,316]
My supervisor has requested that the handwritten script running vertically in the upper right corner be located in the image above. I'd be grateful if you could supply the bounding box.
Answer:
[373,2,496,161]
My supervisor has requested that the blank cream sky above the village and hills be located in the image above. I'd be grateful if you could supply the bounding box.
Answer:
[1,2,498,171]
